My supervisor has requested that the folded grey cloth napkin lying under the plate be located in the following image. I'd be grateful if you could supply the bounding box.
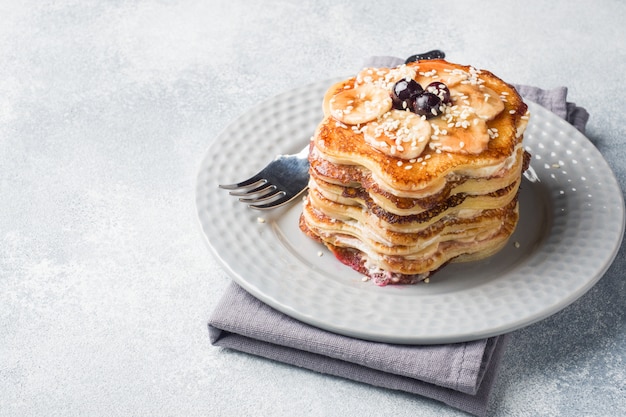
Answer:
[209,57,589,416]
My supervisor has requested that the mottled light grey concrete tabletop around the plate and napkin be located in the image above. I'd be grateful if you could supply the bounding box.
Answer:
[0,0,626,417]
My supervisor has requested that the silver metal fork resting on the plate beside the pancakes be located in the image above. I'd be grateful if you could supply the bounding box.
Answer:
[219,144,309,210]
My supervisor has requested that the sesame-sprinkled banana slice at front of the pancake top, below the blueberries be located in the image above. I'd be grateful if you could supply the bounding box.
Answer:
[363,110,431,159]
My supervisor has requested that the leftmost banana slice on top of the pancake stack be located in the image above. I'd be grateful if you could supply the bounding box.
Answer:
[328,84,392,125]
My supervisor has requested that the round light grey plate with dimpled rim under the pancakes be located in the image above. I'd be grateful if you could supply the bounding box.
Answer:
[196,80,624,344]
